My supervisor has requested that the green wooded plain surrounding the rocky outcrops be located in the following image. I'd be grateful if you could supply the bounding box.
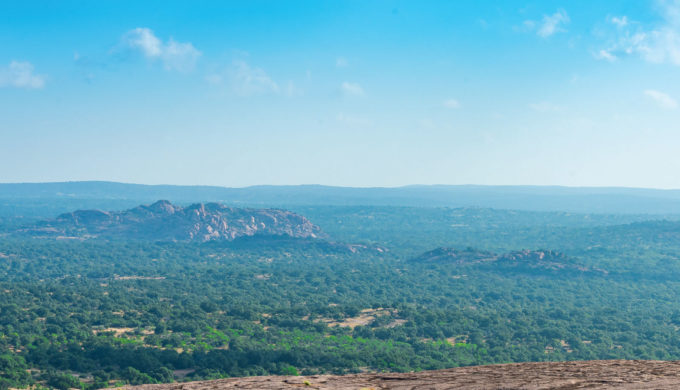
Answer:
[0,206,680,389]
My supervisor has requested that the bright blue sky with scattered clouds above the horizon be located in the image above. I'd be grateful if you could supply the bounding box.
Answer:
[0,0,680,188]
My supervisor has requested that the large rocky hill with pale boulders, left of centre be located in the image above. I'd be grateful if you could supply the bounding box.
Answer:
[32,200,324,242]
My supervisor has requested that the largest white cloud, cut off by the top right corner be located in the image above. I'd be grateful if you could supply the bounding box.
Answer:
[595,0,680,66]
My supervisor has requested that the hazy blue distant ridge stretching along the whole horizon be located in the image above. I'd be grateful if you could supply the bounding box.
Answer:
[0,181,680,214]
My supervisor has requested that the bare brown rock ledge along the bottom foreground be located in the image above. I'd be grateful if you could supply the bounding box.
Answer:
[117,360,680,390]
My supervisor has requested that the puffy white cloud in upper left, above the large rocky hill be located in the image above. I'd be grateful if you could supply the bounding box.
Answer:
[123,27,201,72]
